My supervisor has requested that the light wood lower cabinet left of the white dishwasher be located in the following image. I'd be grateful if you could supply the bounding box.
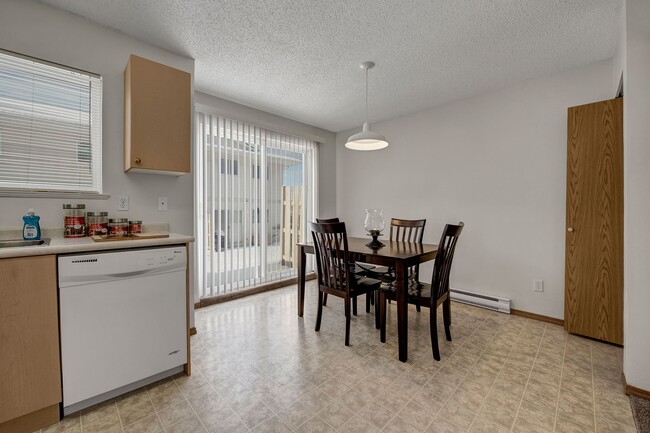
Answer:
[0,255,61,433]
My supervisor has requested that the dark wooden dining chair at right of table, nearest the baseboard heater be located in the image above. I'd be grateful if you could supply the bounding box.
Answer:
[379,222,465,361]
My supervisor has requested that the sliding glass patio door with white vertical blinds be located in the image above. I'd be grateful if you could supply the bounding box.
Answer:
[195,113,317,298]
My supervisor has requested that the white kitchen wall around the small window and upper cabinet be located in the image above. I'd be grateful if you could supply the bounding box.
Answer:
[0,0,194,235]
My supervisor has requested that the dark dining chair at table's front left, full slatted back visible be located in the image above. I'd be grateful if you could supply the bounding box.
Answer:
[309,222,381,346]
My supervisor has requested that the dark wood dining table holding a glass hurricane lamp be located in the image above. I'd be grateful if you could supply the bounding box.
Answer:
[296,237,438,362]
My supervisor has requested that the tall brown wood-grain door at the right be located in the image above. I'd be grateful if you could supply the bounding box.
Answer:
[564,98,623,344]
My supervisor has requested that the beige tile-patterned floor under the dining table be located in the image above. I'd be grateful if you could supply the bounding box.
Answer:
[34,281,636,433]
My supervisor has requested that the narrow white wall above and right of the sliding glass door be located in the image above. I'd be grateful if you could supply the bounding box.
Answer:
[194,92,336,215]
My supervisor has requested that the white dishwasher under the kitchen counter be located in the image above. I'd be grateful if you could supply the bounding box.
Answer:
[58,246,188,415]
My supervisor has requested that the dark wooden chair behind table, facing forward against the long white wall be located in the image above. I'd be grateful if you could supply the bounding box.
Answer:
[359,218,427,311]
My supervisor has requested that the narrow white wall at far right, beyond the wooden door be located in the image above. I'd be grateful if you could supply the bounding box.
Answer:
[623,0,650,391]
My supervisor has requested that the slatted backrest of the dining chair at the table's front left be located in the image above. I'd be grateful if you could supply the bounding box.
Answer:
[309,222,350,294]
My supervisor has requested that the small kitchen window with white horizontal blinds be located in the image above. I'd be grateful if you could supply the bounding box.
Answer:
[0,50,102,193]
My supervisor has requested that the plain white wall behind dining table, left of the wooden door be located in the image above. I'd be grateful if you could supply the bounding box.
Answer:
[337,61,614,318]
